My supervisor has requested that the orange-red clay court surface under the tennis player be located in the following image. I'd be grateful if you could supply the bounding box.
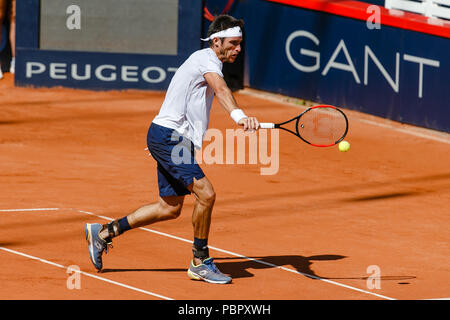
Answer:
[0,74,450,300]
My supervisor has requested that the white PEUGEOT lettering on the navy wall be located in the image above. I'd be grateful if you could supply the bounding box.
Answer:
[25,61,177,83]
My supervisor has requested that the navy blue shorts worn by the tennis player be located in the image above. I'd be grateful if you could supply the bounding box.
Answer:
[147,123,205,197]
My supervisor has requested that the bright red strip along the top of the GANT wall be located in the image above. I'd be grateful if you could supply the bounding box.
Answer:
[267,0,450,38]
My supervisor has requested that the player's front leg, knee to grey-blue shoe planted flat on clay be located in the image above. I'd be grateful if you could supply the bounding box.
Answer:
[188,177,232,284]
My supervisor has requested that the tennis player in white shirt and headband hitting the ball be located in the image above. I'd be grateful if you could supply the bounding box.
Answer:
[85,15,259,283]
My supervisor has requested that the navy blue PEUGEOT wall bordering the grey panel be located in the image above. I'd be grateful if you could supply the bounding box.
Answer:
[15,0,202,90]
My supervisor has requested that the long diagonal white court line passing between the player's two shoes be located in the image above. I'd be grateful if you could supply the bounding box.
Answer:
[76,209,396,300]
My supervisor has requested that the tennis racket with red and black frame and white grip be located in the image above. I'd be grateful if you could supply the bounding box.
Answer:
[259,105,348,147]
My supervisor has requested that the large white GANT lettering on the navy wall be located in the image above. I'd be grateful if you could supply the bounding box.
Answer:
[285,30,440,98]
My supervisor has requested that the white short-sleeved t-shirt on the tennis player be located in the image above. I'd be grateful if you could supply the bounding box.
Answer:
[153,48,223,149]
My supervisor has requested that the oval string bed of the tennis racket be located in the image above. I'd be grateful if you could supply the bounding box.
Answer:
[297,108,347,145]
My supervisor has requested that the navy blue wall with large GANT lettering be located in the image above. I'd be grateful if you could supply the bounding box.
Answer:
[207,0,450,132]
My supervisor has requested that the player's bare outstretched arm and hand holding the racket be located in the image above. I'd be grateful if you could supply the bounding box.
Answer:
[204,72,259,131]
